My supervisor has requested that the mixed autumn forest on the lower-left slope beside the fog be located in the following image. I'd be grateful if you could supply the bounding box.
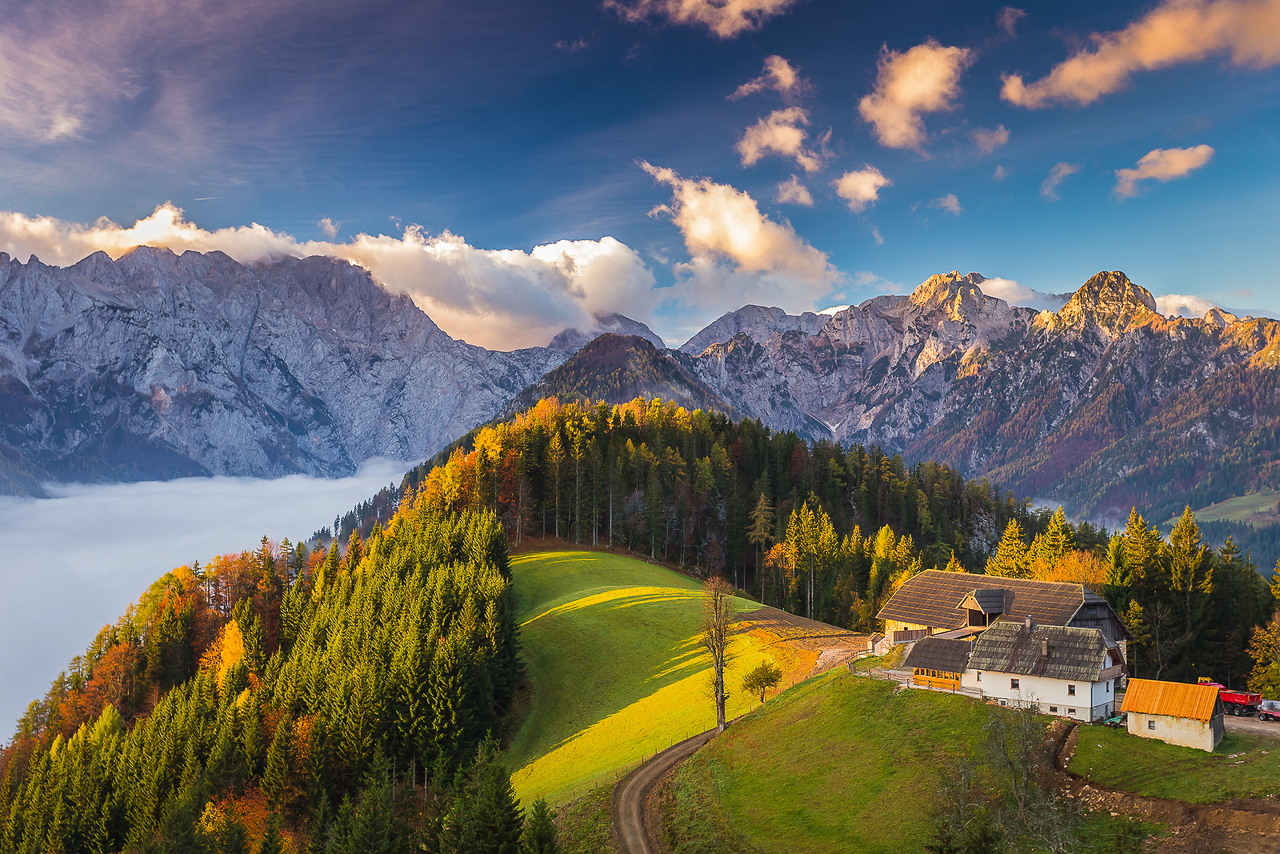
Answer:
[0,507,548,854]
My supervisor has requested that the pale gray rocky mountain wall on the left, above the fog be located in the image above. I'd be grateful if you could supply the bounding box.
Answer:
[0,247,564,480]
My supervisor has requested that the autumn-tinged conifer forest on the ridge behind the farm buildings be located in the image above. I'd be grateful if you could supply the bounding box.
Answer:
[399,398,1280,684]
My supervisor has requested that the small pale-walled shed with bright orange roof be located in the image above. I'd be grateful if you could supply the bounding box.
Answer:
[1123,679,1225,753]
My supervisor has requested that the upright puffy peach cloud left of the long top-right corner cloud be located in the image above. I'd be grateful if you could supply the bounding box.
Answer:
[858,38,974,152]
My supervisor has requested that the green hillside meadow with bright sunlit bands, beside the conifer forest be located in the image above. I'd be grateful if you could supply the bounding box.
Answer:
[507,552,792,803]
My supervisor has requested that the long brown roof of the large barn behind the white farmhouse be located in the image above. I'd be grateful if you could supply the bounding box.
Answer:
[876,570,1105,629]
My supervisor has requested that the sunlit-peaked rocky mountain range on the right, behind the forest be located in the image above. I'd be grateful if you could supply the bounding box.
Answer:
[682,271,1280,519]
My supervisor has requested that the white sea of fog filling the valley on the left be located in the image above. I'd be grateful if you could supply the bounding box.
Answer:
[0,460,410,743]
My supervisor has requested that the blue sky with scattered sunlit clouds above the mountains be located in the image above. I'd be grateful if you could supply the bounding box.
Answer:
[0,0,1280,350]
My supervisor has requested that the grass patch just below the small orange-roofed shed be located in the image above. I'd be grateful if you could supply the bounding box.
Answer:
[1070,726,1280,804]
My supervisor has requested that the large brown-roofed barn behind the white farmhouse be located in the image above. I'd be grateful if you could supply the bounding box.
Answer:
[877,570,1129,643]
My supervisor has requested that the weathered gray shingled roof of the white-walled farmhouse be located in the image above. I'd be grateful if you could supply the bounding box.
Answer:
[969,621,1107,682]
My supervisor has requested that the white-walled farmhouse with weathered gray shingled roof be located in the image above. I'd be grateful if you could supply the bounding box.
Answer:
[960,618,1124,721]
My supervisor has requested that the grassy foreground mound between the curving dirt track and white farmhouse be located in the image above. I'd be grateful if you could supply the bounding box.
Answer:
[677,671,987,854]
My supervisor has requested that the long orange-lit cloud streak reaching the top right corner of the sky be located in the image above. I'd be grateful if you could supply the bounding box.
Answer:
[1001,0,1280,109]
